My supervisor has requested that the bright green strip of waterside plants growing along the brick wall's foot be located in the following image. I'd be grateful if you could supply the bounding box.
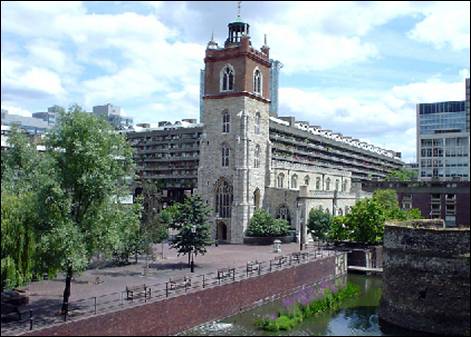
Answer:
[256,283,360,332]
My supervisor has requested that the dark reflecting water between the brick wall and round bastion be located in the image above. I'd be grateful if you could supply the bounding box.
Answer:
[182,274,424,336]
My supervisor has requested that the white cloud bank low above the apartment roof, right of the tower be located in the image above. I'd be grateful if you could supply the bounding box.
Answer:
[279,71,465,161]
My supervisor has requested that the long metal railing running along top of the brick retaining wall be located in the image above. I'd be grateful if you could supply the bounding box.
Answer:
[1,247,337,335]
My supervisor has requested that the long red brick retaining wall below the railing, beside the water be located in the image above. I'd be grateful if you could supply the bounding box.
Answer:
[25,256,339,336]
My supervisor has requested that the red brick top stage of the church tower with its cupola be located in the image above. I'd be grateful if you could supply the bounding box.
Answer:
[204,17,271,103]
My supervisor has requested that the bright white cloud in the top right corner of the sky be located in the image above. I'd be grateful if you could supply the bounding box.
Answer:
[409,1,470,50]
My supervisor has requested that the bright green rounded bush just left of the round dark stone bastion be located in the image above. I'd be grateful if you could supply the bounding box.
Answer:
[346,199,386,244]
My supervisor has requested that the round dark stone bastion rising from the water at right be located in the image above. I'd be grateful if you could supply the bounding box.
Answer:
[379,220,471,336]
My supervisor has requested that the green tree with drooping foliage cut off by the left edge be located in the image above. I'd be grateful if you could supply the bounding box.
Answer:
[1,126,48,290]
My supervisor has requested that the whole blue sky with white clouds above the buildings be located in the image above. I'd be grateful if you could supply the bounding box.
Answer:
[1,1,470,162]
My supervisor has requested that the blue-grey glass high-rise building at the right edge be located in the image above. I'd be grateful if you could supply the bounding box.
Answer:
[417,81,470,181]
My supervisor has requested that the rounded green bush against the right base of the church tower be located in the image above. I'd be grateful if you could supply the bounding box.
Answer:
[245,209,290,237]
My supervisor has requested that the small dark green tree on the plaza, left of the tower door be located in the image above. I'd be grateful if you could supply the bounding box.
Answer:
[168,195,213,265]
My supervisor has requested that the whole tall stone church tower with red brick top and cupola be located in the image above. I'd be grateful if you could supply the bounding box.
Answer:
[198,21,271,243]
